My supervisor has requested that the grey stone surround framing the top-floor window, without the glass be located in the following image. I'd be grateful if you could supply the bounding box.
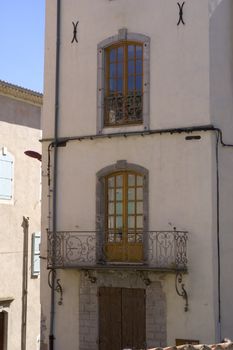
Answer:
[97,28,150,134]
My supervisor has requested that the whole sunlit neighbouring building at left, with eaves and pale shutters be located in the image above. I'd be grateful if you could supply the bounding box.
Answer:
[0,81,42,350]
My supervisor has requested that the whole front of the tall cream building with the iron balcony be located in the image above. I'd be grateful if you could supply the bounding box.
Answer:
[41,0,233,350]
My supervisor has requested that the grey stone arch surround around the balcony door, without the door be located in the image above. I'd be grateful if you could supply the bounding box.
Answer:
[96,160,149,261]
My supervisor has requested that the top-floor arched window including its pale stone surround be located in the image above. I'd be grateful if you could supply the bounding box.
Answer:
[97,28,150,133]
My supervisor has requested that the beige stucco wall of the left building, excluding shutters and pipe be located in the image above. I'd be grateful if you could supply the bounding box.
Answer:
[0,95,41,350]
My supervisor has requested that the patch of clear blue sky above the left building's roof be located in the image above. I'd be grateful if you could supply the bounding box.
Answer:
[0,0,45,92]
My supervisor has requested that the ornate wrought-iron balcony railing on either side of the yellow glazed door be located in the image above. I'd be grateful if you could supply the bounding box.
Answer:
[48,231,188,271]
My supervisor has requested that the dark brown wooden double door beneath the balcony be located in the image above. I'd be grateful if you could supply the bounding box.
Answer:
[99,287,146,350]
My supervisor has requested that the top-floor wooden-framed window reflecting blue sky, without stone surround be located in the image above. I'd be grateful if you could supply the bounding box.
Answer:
[104,42,143,126]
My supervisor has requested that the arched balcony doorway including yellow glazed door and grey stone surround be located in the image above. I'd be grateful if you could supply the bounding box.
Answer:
[97,162,148,262]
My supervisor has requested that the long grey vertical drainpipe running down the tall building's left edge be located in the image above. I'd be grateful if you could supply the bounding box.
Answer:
[49,0,61,350]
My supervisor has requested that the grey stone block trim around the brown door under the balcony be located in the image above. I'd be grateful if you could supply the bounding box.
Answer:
[79,271,167,350]
